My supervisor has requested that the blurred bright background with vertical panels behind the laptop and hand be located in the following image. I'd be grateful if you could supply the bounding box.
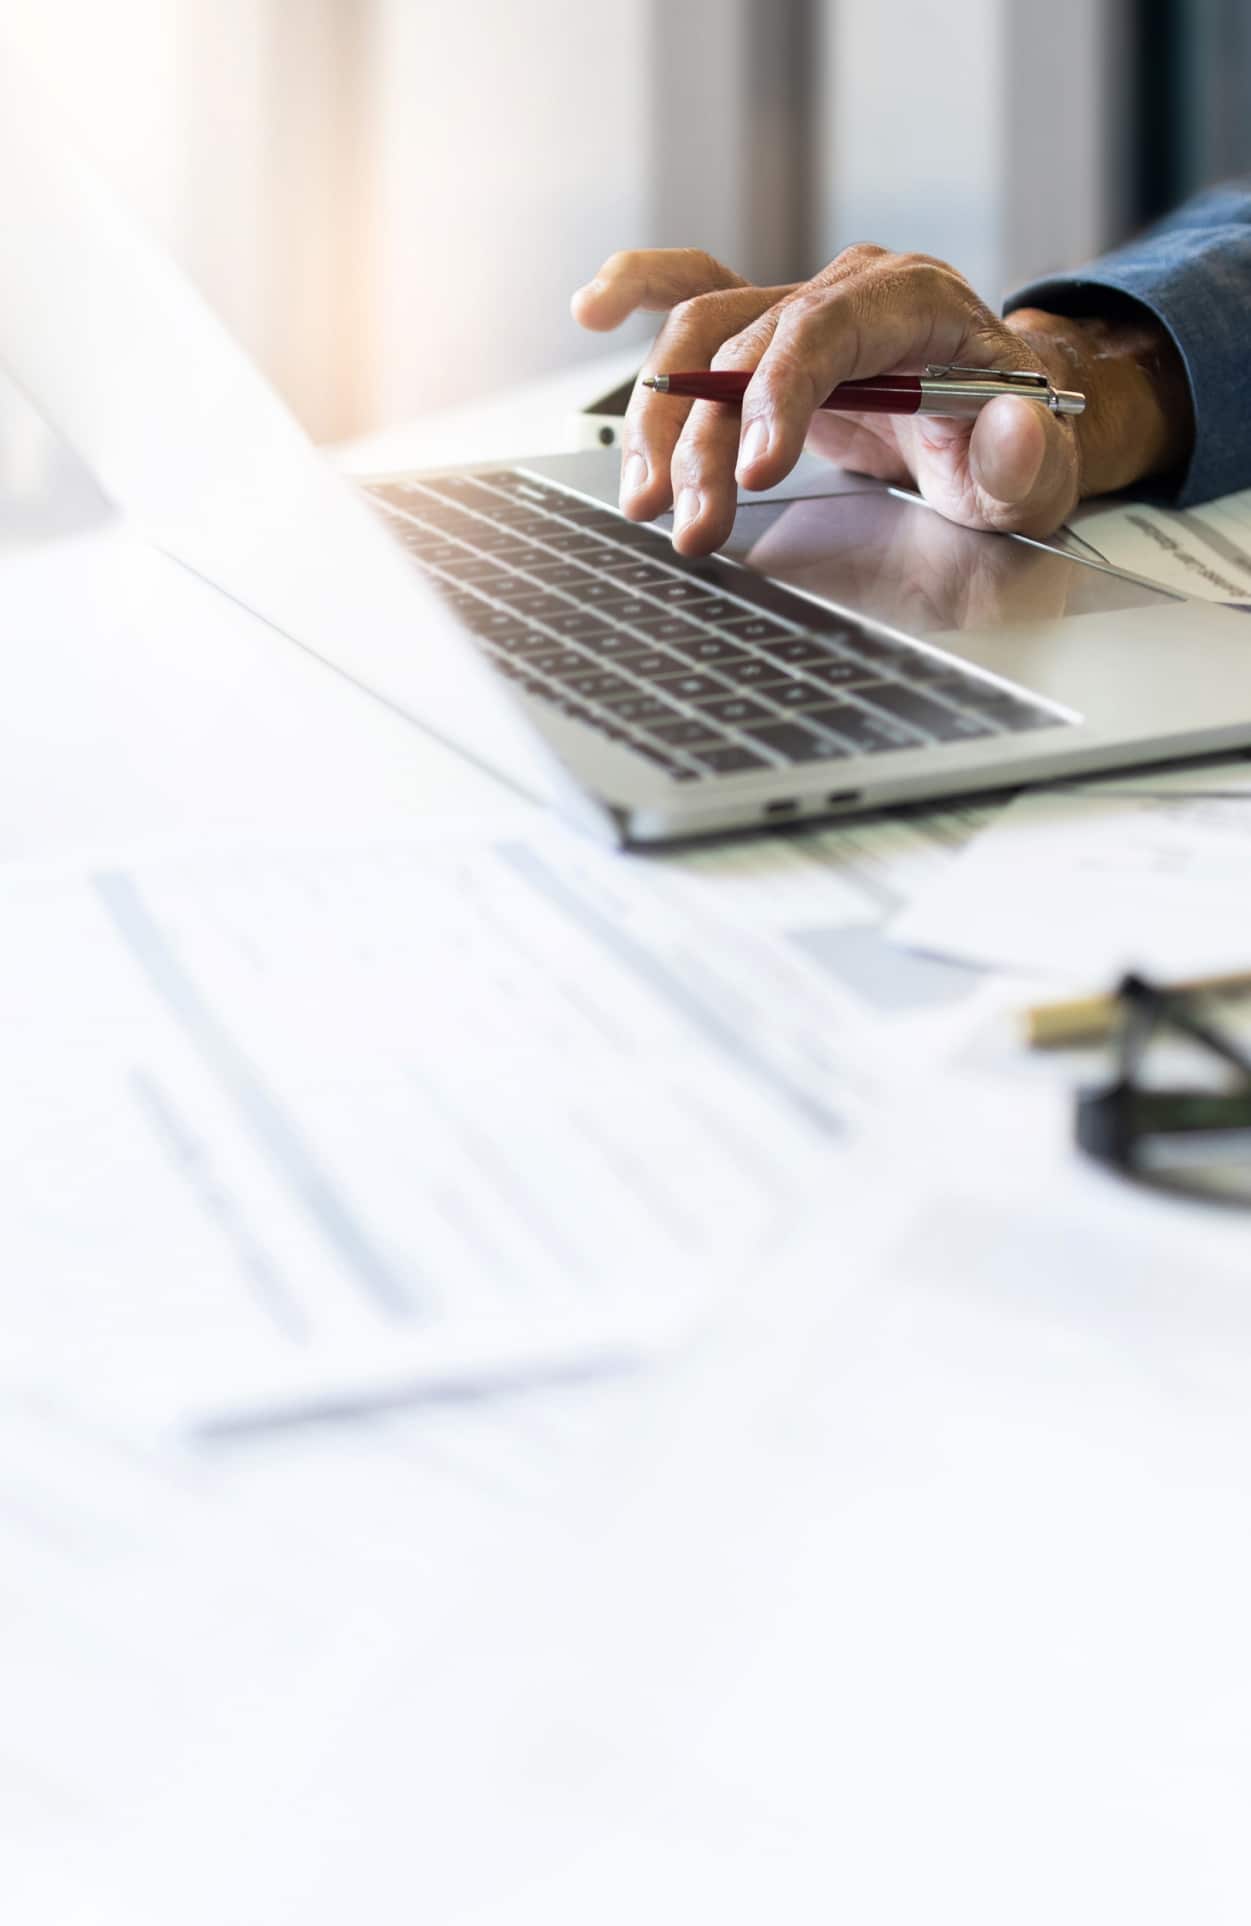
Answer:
[4,0,1251,441]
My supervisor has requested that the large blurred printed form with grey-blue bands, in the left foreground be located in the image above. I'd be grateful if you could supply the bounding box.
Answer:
[0,832,862,1427]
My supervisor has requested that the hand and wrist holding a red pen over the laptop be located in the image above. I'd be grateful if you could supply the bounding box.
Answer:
[574,247,1191,555]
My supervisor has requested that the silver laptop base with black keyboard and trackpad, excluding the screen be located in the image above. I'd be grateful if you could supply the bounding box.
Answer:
[364,451,1251,844]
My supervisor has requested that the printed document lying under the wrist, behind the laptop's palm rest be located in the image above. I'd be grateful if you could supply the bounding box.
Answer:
[1072,489,1251,603]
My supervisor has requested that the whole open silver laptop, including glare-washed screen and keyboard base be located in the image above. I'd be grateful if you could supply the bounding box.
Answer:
[9,69,1251,846]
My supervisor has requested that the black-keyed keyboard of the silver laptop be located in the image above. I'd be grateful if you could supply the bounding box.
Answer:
[368,472,1068,782]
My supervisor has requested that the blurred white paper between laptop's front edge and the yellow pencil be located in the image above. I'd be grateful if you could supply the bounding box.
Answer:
[891,781,1251,982]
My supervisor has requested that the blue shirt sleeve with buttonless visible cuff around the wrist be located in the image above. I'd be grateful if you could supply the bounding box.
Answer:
[1005,183,1251,507]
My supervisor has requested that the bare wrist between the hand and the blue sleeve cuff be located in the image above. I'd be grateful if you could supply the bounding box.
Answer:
[1007,295,1193,497]
